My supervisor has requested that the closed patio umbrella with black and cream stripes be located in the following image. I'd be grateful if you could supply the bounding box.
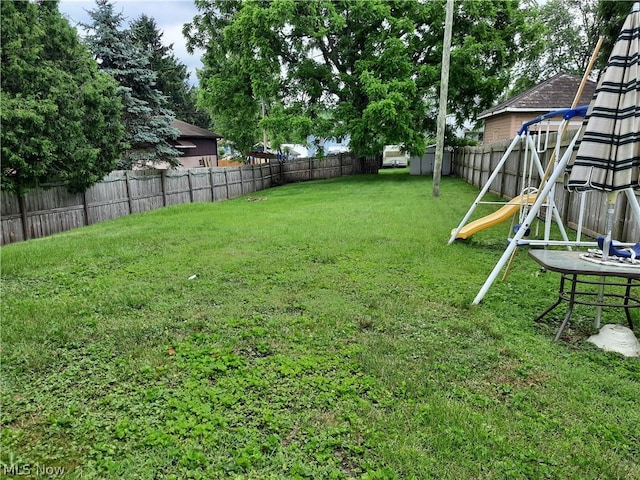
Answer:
[566,3,640,192]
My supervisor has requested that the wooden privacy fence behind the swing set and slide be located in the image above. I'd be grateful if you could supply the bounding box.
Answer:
[454,131,640,243]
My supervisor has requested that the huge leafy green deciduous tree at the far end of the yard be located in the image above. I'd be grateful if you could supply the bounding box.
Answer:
[184,0,531,159]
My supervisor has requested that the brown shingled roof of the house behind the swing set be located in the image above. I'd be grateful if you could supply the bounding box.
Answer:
[478,73,596,120]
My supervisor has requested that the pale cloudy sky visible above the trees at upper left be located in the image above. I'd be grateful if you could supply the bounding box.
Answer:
[59,0,202,84]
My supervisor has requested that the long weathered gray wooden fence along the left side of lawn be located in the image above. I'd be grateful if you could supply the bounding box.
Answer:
[1,155,363,245]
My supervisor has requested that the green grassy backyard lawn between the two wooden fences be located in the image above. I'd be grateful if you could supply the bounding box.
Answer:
[0,169,640,480]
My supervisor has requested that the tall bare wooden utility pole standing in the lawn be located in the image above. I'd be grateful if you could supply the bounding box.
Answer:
[433,0,453,197]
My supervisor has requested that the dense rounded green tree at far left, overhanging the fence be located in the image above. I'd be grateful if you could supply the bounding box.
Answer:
[0,1,123,193]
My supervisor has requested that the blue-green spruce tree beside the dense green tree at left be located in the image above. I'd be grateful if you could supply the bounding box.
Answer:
[84,0,180,168]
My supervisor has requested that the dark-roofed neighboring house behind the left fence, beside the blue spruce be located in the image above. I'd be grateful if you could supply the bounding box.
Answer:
[171,120,222,167]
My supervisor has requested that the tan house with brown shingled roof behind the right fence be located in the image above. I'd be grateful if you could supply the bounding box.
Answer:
[478,73,596,144]
